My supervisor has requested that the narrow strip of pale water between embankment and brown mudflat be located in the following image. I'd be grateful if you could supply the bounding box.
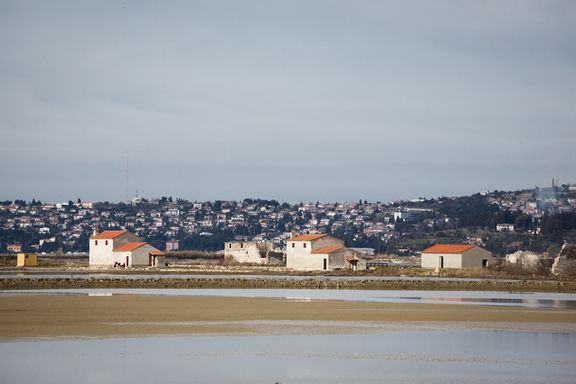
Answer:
[0,288,576,309]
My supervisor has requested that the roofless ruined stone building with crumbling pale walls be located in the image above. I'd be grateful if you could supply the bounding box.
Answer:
[224,241,284,265]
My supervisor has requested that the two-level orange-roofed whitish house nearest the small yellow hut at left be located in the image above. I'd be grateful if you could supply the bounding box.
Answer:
[89,231,165,267]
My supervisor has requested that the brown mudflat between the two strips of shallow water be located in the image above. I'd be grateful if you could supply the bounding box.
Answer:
[0,295,576,340]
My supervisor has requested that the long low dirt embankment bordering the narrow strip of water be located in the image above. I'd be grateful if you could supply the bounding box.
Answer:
[0,277,576,293]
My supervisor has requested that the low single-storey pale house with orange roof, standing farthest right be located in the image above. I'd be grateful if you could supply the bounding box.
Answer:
[422,244,493,269]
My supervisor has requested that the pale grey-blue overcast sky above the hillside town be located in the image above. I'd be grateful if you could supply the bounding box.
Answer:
[0,0,576,203]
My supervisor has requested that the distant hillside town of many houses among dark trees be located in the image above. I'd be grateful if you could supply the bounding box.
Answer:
[0,184,576,256]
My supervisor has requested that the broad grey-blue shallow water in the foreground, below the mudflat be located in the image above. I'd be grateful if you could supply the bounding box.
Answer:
[0,328,576,384]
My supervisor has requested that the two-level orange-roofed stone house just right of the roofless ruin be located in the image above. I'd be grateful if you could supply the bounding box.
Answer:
[286,234,366,271]
